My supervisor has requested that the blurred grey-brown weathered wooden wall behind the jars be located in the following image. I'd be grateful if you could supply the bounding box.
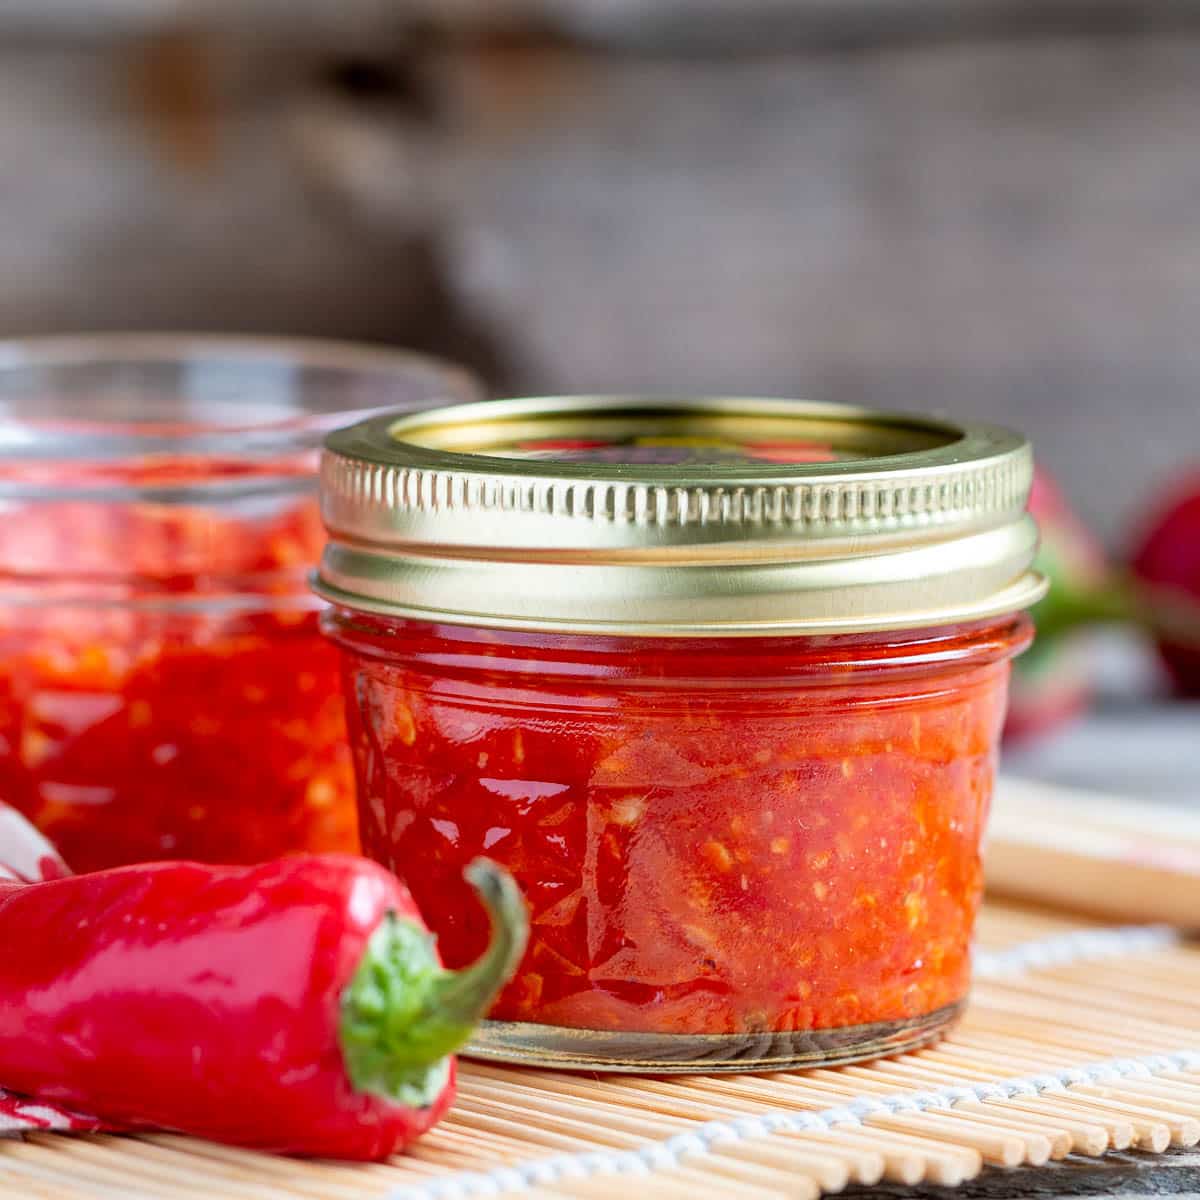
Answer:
[0,0,1200,541]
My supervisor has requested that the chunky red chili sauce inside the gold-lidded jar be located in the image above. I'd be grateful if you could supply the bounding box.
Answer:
[326,610,1031,1033]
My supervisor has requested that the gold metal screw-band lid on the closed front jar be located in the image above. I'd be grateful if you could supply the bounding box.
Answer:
[314,396,1045,636]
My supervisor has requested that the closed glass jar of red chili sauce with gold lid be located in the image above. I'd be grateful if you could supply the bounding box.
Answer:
[317,398,1044,1072]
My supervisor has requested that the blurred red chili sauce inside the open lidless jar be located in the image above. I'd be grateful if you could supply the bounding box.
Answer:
[0,458,358,871]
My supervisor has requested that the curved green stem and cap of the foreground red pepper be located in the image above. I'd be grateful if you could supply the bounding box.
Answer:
[340,858,528,1108]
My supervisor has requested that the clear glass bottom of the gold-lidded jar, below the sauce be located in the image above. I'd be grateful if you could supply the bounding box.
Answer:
[462,1002,964,1075]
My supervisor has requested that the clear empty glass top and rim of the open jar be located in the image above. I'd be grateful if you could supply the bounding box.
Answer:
[0,332,481,499]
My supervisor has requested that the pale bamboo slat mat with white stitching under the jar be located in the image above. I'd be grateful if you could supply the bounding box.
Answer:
[0,904,1200,1200]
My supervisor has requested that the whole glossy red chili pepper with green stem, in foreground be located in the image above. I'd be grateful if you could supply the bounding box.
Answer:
[0,854,524,1160]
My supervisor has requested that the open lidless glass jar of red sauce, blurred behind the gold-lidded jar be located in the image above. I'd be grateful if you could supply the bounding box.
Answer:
[0,335,479,870]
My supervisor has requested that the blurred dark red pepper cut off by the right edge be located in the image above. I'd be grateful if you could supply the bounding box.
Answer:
[1130,470,1200,696]
